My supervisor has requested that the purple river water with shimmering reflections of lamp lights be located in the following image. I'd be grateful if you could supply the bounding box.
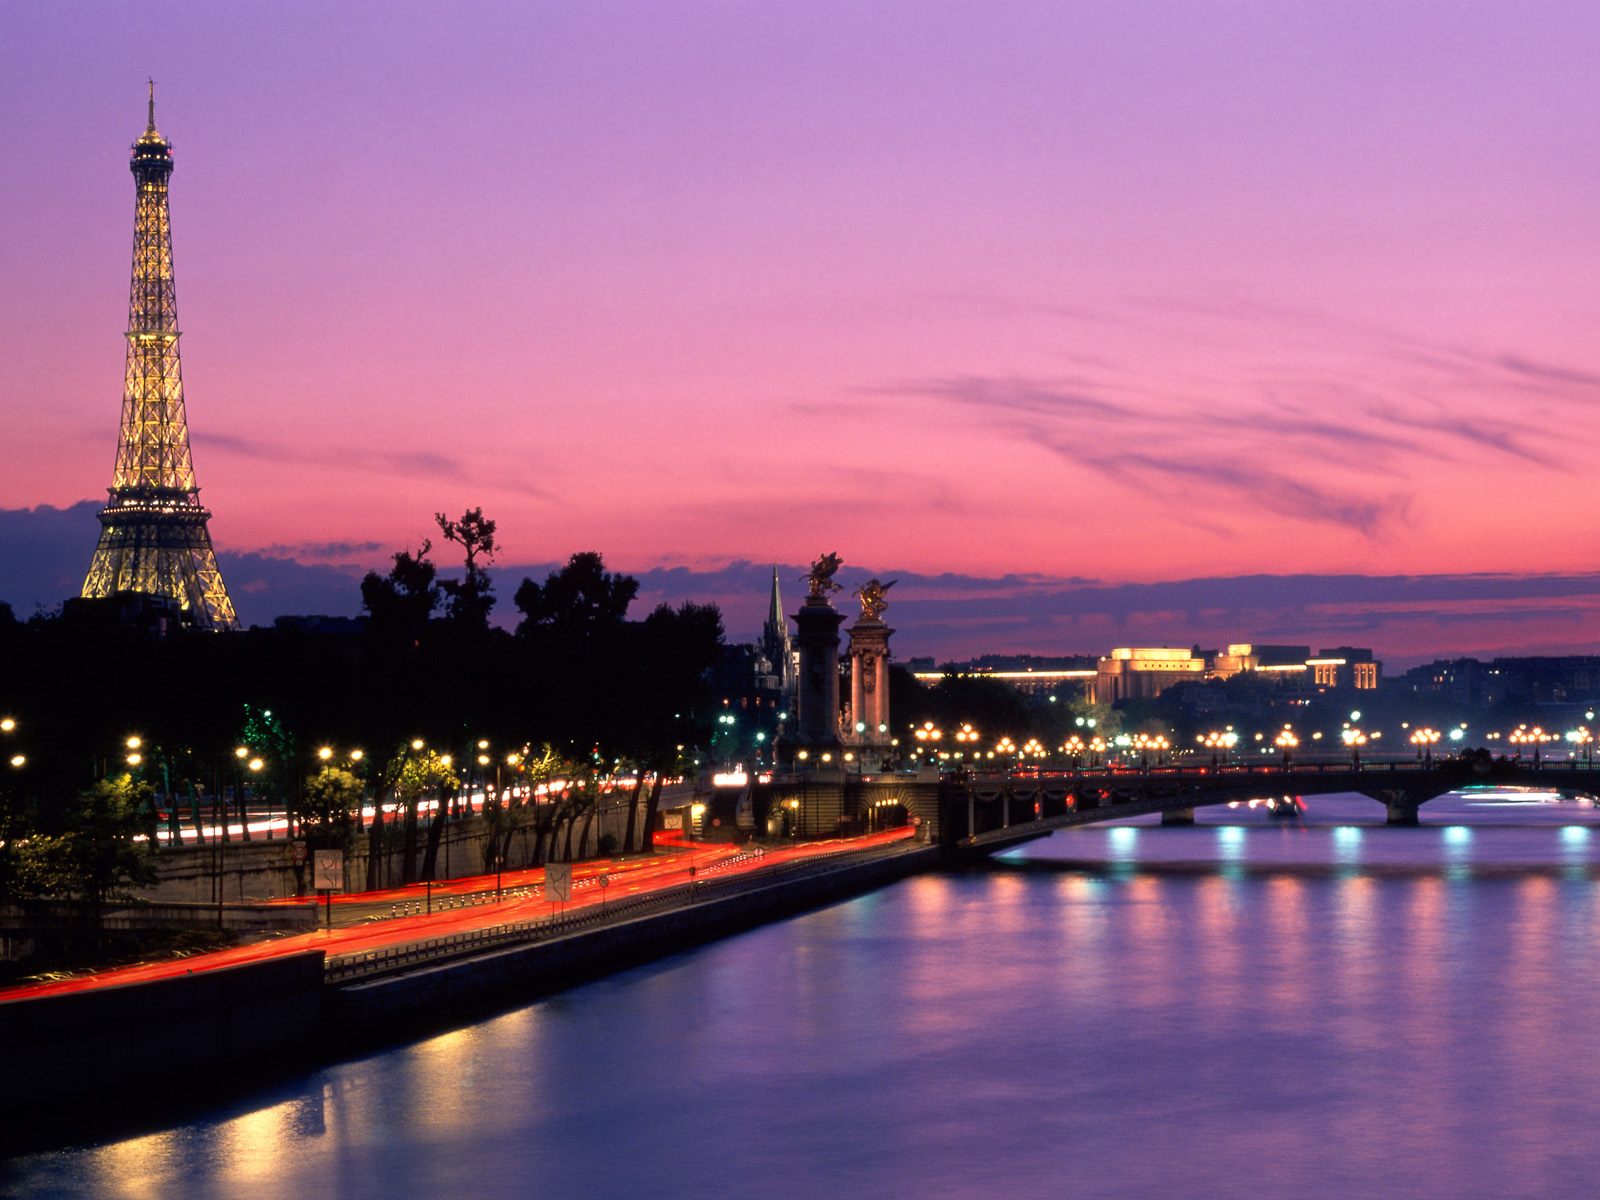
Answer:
[9,794,1600,1200]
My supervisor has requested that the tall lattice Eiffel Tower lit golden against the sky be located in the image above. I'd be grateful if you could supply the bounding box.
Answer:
[83,82,238,629]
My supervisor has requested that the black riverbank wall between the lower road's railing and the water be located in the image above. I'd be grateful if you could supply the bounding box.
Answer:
[0,845,944,1154]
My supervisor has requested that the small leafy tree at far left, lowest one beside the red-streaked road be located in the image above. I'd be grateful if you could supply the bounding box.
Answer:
[19,774,155,938]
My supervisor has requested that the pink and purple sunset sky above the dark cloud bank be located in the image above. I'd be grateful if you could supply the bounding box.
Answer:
[0,0,1600,650]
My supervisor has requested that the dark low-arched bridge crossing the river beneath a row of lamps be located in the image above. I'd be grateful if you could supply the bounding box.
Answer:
[939,750,1600,853]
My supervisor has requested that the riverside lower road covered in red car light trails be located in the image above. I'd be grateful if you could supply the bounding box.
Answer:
[0,827,914,1003]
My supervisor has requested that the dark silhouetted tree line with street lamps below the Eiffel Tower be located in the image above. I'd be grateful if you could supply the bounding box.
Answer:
[0,509,723,902]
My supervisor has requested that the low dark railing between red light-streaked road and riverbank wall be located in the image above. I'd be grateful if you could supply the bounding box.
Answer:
[325,843,902,984]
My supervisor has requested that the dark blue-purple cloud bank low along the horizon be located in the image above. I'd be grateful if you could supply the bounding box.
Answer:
[0,501,1600,666]
